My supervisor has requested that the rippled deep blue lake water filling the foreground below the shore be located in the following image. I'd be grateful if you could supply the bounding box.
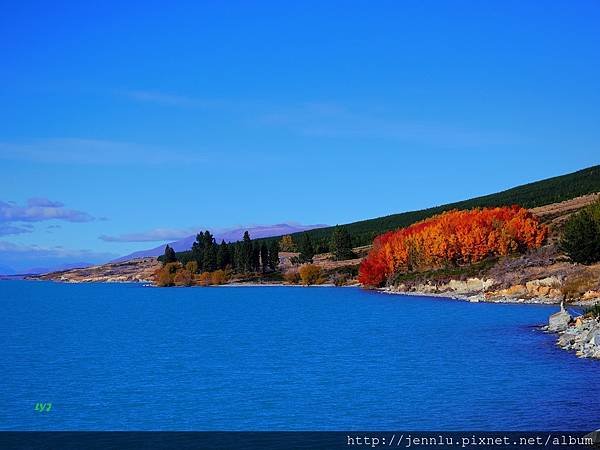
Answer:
[0,281,600,430]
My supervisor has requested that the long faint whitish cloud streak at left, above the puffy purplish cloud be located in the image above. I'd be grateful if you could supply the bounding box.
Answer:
[0,138,207,166]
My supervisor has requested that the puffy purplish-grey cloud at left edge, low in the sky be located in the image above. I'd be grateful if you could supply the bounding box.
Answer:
[0,198,94,224]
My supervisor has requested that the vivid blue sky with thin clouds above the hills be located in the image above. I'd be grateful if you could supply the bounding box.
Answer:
[0,1,600,266]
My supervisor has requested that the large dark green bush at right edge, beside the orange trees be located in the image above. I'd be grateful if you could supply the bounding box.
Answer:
[560,201,600,264]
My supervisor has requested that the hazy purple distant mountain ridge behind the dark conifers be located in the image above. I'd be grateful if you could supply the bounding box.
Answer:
[112,223,329,262]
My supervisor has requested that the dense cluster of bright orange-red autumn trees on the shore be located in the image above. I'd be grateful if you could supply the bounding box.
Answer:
[358,206,548,286]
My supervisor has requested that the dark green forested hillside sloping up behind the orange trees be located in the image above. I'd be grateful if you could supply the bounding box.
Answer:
[173,165,600,258]
